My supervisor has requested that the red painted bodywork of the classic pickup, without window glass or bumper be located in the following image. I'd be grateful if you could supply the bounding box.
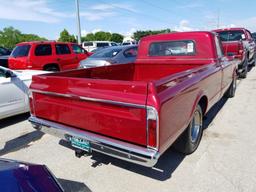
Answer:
[30,32,237,153]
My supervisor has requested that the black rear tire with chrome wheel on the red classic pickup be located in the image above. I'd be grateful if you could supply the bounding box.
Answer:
[173,105,203,155]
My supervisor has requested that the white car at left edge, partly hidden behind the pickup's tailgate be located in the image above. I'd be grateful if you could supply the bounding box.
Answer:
[0,66,46,119]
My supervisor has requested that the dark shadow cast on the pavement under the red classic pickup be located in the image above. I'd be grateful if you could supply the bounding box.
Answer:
[59,98,231,181]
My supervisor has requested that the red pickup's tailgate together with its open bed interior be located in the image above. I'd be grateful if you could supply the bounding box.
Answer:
[30,63,206,146]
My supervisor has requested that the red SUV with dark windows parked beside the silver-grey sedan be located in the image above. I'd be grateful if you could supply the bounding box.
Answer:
[8,41,90,71]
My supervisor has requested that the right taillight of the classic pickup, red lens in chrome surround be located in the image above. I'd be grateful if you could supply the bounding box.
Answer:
[147,107,159,148]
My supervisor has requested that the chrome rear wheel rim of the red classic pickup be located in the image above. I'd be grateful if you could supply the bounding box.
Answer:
[191,111,202,143]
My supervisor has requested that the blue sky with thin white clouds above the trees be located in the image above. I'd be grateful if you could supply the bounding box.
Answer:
[0,0,256,40]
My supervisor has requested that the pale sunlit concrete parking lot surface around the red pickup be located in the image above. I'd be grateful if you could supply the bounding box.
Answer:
[0,68,256,192]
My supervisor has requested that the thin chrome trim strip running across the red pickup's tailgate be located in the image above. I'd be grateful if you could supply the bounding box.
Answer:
[30,89,146,109]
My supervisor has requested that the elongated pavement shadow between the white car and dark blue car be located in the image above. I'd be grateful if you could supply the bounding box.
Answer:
[0,131,44,156]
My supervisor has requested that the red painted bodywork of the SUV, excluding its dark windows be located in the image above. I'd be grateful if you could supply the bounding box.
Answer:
[8,41,91,71]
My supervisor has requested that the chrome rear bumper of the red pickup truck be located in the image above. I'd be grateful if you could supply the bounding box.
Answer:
[29,116,160,167]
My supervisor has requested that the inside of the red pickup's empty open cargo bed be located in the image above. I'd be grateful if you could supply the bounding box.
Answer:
[52,63,200,82]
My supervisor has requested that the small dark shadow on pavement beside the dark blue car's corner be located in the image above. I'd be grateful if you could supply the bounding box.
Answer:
[58,179,91,192]
